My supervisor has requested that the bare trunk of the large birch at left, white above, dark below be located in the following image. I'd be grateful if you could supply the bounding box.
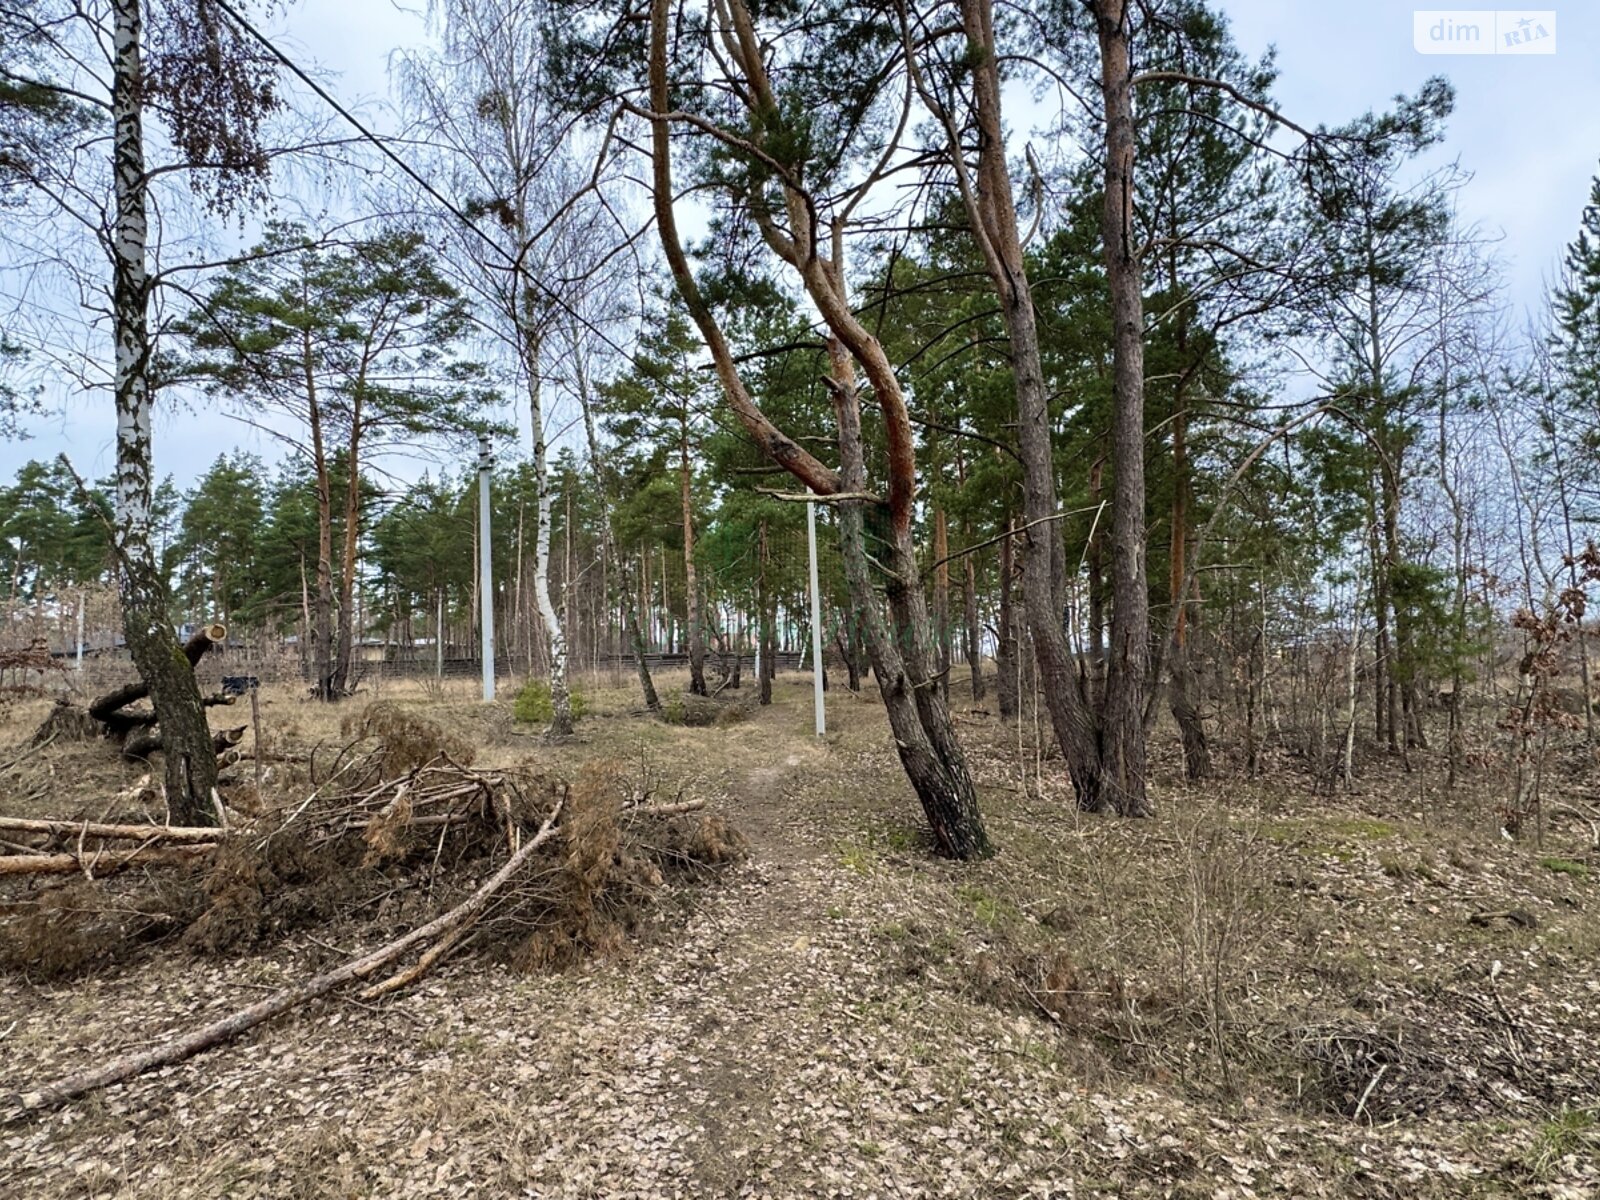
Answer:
[110,0,216,826]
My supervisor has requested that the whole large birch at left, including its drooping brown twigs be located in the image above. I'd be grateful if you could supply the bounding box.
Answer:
[3,0,282,824]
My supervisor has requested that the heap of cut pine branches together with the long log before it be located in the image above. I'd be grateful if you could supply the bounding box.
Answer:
[0,713,744,1117]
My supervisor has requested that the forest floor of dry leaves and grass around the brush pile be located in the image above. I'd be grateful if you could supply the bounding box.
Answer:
[0,677,1600,1200]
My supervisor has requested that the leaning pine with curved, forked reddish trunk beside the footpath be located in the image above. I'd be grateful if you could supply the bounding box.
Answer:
[611,0,992,859]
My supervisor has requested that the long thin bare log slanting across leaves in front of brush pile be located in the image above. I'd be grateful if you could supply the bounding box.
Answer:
[0,797,565,1122]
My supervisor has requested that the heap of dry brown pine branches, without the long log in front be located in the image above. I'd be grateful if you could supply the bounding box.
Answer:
[0,704,744,990]
